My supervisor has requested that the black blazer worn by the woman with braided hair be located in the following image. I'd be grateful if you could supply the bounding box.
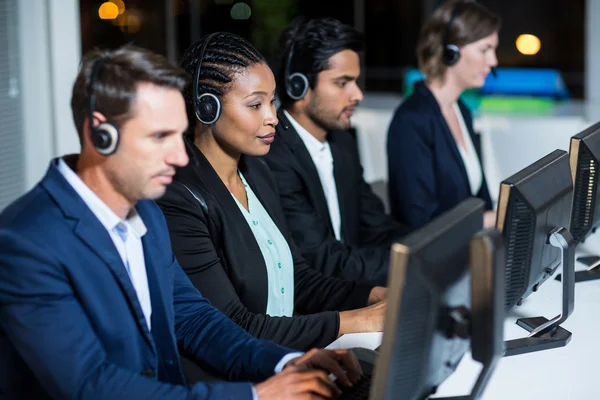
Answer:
[158,141,372,356]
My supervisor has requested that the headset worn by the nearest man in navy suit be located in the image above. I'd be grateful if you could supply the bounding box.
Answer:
[88,56,119,156]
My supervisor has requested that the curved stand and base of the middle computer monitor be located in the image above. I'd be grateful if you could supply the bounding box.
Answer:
[504,228,576,357]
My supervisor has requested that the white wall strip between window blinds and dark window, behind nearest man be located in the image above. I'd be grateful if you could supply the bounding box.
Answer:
[18,0,81,189]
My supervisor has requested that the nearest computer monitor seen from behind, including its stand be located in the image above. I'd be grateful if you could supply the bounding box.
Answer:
[369,198,505,400]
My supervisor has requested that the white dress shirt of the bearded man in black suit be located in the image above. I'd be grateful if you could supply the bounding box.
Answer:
[283,110,342,240]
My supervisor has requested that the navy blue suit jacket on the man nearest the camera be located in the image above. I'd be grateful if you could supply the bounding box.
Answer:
[0,160,290,400]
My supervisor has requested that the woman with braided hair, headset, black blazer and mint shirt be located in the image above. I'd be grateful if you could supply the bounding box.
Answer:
[158,32,385,381]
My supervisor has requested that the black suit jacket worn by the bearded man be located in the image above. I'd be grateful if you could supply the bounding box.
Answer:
[264,112,408,285]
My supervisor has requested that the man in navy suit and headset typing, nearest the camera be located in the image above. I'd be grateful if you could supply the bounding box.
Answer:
[0,46,359,400]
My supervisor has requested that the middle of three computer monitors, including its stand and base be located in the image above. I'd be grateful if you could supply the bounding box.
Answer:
[496,150,575,355]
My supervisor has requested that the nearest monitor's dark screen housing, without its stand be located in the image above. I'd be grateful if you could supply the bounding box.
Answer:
[370,198,484,400]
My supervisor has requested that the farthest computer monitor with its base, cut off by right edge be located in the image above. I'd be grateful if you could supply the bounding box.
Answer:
[556,123,600,282]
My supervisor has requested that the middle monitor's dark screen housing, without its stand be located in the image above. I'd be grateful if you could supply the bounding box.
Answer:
[496,150,573,312]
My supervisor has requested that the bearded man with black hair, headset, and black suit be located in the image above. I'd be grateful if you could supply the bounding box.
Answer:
[265,18,407,285]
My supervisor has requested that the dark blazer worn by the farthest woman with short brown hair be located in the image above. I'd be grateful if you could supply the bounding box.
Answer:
[387,81,492,228]
